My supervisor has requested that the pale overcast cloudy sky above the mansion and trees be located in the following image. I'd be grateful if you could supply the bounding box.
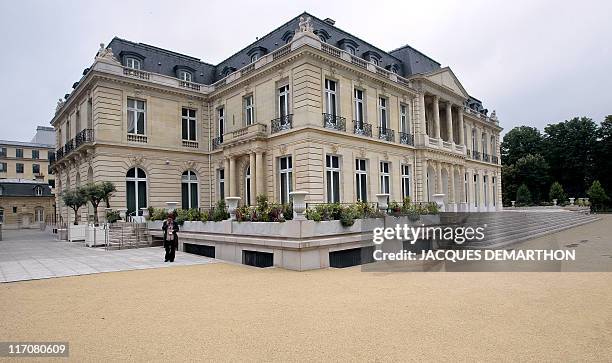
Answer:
[0,0,612,141]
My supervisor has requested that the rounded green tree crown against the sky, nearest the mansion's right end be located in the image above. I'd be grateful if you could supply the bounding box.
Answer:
[500,126,542,165]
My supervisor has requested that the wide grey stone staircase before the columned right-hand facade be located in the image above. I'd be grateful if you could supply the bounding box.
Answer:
[439,210,599,249]
